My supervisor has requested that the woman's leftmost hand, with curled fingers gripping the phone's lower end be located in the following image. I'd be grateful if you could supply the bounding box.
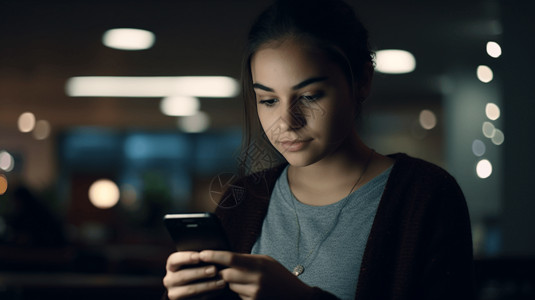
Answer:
[163,251,226,300]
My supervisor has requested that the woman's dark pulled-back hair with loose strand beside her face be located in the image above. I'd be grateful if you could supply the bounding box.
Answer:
[240,0,373,175]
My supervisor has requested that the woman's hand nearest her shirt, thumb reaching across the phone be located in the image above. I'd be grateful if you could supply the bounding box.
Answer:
[200,250,312,299]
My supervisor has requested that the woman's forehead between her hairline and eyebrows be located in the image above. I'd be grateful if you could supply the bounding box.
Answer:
[251,39,338,87]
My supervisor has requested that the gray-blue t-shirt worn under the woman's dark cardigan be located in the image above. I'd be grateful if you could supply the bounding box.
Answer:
[251,167,392,299]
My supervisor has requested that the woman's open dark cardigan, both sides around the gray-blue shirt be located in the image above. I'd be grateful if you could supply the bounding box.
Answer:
[216,154,474,300]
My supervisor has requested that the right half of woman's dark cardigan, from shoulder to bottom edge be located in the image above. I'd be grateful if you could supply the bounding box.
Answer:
[357,154,474,300]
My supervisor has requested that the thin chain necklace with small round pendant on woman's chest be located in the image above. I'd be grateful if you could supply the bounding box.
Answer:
[292,149,375,276]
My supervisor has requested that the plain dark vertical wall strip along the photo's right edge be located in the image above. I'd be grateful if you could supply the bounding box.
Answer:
[501,0,535,255]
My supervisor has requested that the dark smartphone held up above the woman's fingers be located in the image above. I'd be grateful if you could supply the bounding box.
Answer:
[164,212,231,251]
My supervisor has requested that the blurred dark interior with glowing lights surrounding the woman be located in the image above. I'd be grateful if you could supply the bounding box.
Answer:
[0,0,535,299]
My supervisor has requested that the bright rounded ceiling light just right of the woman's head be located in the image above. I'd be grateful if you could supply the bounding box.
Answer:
[375,49,416,74]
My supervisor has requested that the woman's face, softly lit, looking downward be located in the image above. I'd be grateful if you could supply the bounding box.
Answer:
[251,39,356,166]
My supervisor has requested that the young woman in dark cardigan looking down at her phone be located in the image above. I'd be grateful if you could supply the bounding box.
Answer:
[164,0,473,299]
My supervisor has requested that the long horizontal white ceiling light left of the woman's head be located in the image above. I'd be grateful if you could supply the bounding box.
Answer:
[65,76,239,98]
